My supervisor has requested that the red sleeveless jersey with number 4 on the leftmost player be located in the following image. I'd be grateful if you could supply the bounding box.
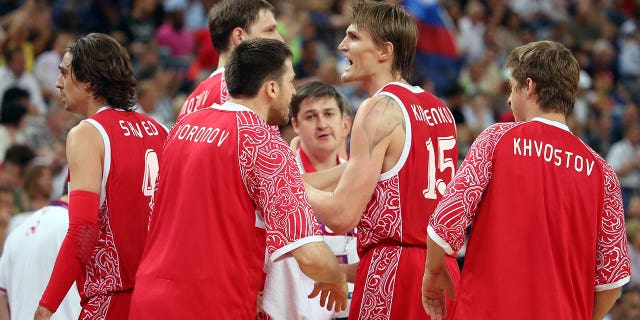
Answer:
[80,108,167,297]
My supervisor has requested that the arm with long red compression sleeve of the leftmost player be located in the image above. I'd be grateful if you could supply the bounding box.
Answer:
[39,122,104,312]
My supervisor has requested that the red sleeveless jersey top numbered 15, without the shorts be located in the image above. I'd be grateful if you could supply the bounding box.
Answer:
[358,83,458,247]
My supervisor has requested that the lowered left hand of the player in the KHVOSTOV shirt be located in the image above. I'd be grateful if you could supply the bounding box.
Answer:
[422,268,456,320]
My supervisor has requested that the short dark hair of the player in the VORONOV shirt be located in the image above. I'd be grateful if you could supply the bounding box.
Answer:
[225,38,292,97]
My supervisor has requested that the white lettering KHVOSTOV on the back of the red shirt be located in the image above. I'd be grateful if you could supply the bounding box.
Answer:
[513,138,596,176]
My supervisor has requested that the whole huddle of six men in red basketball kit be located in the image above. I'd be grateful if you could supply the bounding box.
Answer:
[1,0,630,320]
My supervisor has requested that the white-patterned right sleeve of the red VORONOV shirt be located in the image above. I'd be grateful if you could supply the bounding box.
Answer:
[239,117,322,259]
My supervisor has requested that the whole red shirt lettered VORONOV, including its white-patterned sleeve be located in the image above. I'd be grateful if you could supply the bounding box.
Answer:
[130,102,322,319]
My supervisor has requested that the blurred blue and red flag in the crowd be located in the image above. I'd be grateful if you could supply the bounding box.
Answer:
[402,0,462,91]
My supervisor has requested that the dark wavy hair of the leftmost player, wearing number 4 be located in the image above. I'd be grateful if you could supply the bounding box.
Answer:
[67,33,136,111]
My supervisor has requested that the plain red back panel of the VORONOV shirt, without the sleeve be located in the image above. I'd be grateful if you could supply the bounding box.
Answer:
[132,104,271,319]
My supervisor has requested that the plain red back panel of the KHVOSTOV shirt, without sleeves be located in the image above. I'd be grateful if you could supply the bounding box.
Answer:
[457,119,615,319]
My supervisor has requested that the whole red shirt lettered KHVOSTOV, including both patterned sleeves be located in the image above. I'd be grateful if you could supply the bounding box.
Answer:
[429,118,630,320]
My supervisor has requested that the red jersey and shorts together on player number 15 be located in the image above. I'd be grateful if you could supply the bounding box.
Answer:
[349,83,458,319]
